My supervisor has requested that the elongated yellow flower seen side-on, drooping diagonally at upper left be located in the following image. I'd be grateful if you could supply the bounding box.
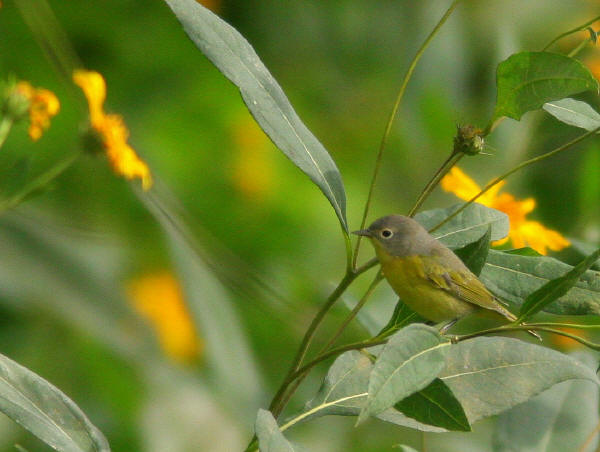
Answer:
[73,70,152,190]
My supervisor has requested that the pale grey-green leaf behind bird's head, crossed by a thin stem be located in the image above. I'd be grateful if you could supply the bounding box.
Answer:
[415,203,509,249]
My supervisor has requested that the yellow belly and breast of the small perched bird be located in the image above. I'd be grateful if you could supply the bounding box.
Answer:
[380,256,476,322]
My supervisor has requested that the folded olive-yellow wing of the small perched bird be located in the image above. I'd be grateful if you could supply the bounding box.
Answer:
[424,259,514,320]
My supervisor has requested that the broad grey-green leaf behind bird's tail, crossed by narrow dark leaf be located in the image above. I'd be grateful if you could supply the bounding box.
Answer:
[480,250,600,315]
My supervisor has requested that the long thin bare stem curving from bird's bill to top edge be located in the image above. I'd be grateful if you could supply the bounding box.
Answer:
[352,0,460,268]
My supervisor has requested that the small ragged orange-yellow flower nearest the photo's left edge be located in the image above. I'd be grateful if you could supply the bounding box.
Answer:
[15,81,60,141]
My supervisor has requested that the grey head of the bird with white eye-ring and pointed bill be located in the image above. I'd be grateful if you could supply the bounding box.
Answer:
[353,215,440,259]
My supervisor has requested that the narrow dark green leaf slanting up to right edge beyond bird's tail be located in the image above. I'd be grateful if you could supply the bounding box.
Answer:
[519,248,600,320]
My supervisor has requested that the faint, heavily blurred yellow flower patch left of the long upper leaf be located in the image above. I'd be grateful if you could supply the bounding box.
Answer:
[230,112,274,201]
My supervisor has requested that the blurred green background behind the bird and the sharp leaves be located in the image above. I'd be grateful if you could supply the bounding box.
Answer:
[0,0,600,452]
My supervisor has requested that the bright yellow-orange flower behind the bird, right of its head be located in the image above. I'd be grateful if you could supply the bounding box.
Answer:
[441,167,570,254]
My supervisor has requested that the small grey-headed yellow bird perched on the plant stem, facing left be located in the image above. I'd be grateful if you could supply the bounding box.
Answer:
[353,215,541,340]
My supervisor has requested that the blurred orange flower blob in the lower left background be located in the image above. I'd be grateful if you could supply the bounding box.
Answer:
[127,271,202,363]
